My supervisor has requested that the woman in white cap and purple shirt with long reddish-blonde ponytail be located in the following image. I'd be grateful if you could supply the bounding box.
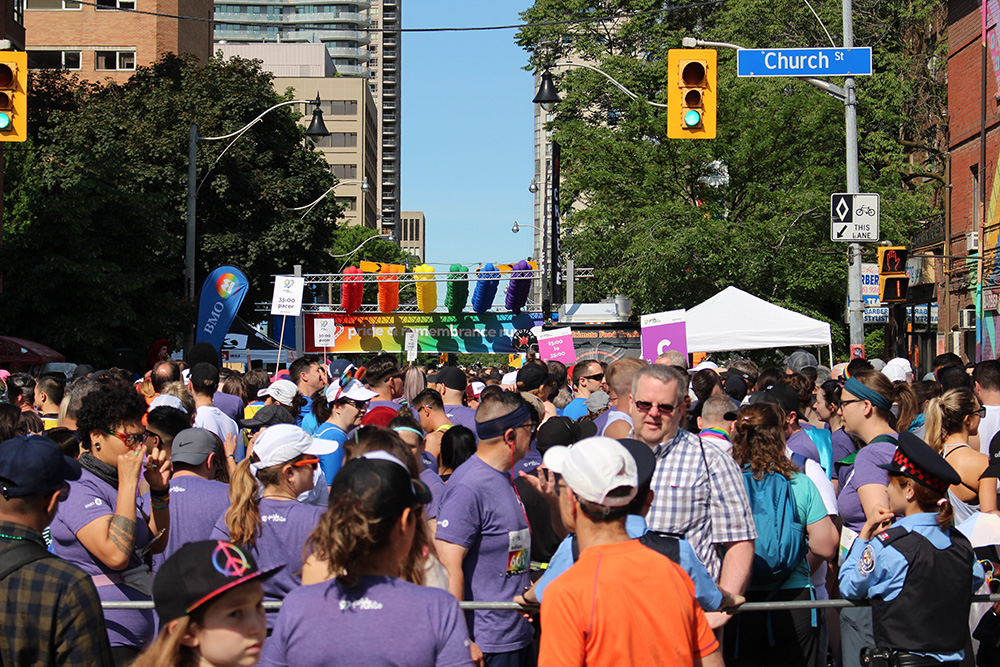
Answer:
[212,424,336,622]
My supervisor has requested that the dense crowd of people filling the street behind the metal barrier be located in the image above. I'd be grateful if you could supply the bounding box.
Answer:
[0,344,1000,667]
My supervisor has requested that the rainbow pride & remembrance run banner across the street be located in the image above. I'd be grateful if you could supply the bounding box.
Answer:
[305,313,542,354]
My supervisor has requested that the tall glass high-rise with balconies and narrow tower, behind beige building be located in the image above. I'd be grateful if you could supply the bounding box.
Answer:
[215,0,401,238]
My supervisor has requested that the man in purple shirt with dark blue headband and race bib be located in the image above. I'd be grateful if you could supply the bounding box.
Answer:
[435,391,534,666]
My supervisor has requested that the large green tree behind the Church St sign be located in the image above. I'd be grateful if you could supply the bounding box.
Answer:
[518,0,947,340]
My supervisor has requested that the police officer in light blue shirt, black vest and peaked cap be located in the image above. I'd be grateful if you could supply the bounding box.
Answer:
[840,433,984,667]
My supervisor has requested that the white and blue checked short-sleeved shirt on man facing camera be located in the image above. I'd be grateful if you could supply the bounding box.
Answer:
[646,429,757,581]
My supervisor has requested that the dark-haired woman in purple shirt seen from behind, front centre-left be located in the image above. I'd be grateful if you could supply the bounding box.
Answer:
[263,451,472,667]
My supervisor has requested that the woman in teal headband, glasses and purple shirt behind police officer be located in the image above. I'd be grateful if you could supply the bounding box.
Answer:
[837,370,917,667]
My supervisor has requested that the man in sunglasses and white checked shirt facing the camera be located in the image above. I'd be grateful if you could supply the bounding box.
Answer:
[629,364,757,627]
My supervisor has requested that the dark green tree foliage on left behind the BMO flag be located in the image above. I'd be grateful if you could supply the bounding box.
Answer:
[0,55,378,360]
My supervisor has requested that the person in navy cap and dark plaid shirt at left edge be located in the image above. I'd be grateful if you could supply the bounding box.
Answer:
[0,435,114,667]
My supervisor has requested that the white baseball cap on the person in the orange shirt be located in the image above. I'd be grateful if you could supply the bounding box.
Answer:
[544,436,639,507]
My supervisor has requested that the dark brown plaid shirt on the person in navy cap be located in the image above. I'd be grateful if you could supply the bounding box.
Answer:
[0,521,114,667]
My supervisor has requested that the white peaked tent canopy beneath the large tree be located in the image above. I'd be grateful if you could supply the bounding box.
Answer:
[685,286,833,352]
